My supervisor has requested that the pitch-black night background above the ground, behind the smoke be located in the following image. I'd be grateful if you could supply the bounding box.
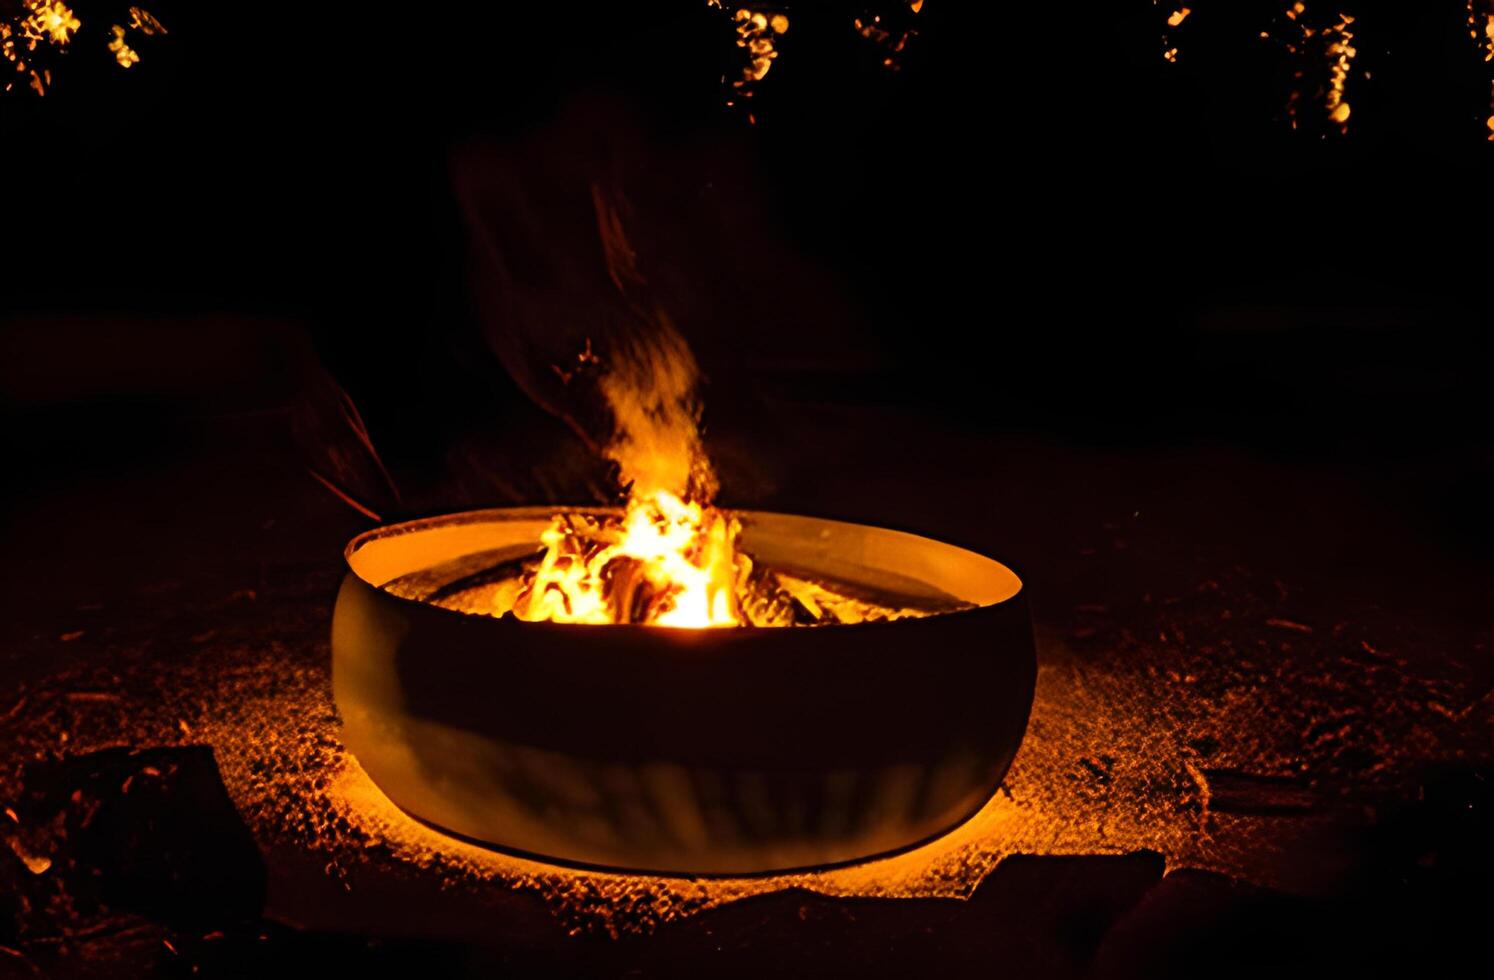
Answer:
[0,0,1491,513]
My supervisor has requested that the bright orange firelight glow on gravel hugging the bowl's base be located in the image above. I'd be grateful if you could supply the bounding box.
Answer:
[190,642,1356,937]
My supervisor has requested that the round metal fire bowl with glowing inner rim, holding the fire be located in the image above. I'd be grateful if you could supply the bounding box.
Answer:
[332,508,1035,874]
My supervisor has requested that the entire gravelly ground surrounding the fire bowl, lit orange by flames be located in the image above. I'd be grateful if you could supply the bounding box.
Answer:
[0,406,1494,974]
